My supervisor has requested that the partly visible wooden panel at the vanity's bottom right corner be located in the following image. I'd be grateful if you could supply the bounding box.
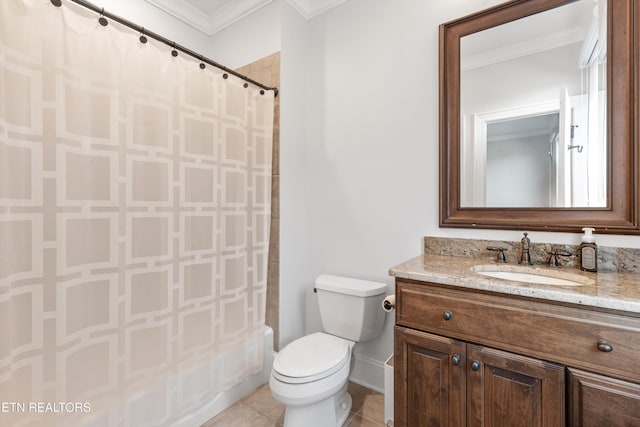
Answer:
[569,369,640,427]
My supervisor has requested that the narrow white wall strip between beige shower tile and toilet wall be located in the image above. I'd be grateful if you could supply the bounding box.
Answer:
[279,0,315,348]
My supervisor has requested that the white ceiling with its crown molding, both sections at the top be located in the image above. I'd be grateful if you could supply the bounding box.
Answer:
[146,0,347,36]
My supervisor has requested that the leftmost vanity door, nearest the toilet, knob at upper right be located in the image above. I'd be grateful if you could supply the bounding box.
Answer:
[394,326,466,427]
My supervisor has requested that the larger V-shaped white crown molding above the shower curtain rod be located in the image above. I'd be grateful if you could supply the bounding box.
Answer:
[145,0,274,36]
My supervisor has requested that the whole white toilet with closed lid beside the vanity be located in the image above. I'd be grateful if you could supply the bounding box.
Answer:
[269,274,387,427]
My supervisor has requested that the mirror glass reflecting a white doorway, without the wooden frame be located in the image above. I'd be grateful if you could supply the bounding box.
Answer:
[460,0,608,207]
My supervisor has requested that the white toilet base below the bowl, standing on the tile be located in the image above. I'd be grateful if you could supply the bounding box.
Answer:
[284,384,352,427]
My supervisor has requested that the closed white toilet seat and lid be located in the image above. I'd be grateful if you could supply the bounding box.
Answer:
[273,332,351,384]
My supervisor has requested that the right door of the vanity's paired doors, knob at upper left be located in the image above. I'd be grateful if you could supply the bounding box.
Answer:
[466,344,565,427]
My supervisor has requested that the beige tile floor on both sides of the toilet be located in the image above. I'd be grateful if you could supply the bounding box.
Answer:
[201,382,385,427]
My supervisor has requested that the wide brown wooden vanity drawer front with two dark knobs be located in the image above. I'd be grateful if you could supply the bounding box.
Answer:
[396,279,640,382]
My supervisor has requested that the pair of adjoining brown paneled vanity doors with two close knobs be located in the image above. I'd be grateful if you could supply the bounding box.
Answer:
[394,327,564,427]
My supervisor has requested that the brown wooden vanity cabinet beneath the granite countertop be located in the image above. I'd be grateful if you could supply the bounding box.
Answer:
[394,278,640,427]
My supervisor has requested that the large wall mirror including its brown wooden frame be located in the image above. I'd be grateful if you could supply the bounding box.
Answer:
[440,0,640,234]
